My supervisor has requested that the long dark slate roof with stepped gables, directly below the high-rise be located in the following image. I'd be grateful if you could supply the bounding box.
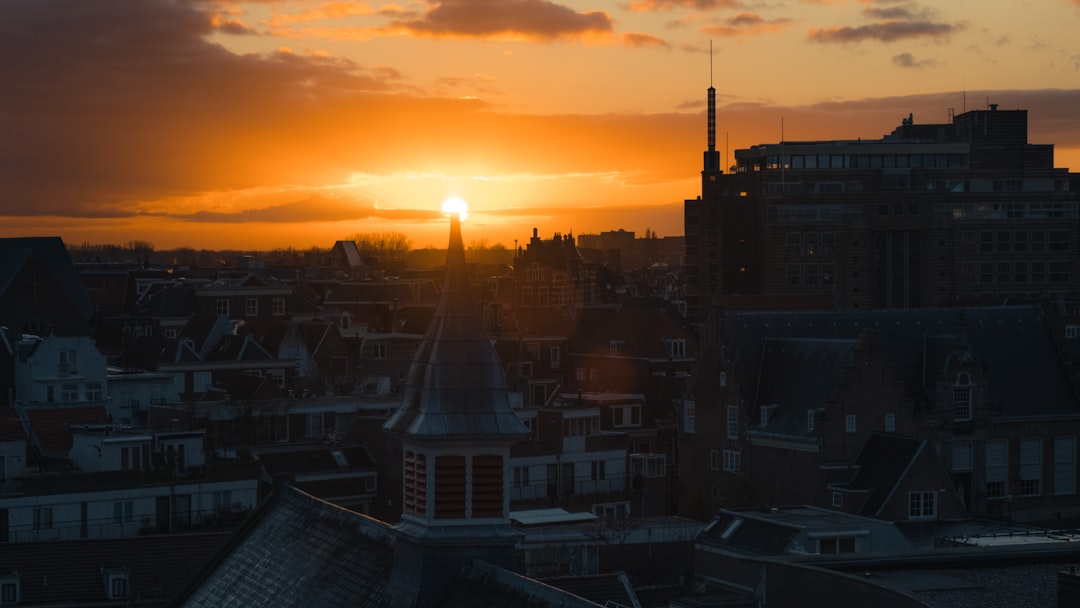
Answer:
[724,306,1080,416]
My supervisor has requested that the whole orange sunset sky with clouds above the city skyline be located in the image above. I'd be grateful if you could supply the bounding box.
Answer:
[0,0,1080,249]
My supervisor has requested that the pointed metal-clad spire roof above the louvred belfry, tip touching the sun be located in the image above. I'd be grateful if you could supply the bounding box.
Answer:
[384,215,528,440]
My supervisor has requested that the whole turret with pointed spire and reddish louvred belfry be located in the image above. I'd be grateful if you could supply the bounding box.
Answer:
[383,209,529,606]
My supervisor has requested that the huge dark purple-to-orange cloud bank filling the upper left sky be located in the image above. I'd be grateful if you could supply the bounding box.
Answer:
[0,0,480,217]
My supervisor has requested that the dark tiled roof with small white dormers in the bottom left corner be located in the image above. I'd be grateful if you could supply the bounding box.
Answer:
[0,532,229,606]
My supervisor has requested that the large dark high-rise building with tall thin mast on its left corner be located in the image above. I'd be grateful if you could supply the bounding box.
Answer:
[685,95,1080,319]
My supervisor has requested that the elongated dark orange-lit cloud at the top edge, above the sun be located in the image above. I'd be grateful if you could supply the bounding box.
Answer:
[391,0,612,40]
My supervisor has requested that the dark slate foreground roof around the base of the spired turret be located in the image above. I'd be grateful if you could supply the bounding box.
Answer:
[178,486,597,608]
